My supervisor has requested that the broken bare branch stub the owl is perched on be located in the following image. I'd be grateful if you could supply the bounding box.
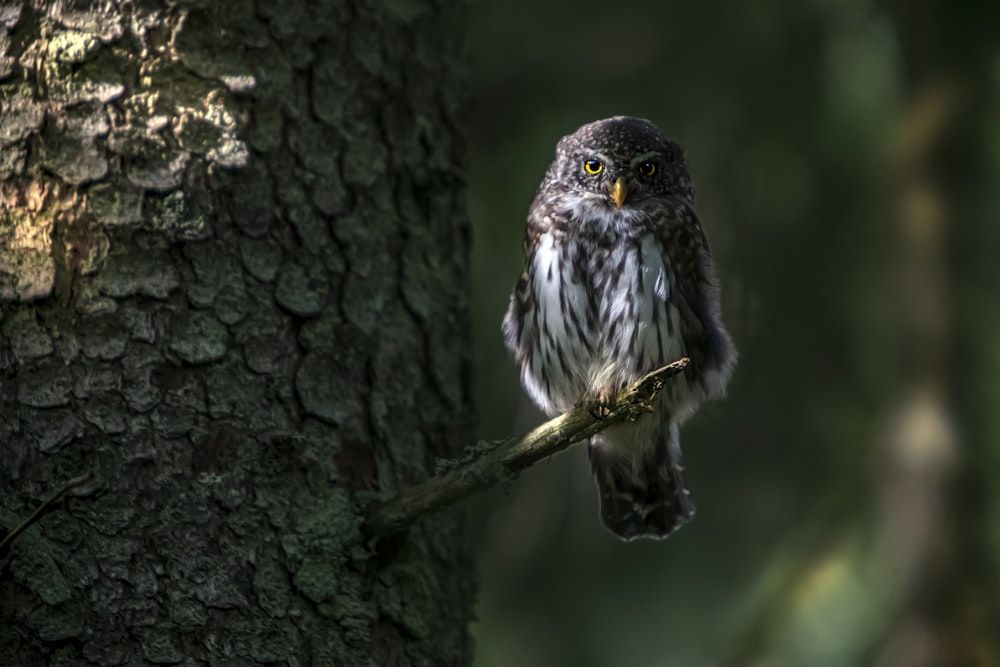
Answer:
[365,357,688,537]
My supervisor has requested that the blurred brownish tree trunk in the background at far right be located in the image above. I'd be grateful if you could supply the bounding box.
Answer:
[877,0,1000,667]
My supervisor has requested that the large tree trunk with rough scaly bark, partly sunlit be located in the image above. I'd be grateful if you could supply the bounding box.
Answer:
[0,0,475,667]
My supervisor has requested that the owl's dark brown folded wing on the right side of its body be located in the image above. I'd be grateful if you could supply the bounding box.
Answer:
[658,200,735,396]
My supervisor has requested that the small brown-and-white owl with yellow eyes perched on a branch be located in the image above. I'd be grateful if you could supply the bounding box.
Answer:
[503,116,736,540]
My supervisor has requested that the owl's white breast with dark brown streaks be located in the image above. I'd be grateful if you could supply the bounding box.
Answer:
[521,232,685,414]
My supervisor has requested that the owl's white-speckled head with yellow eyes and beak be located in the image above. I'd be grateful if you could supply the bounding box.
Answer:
[548,116,694,210]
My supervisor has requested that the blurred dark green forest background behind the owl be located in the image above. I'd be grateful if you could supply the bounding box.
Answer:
[468,0,1000,667]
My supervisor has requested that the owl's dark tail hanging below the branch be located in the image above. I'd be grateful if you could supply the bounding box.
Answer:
[588,424,694,540]
